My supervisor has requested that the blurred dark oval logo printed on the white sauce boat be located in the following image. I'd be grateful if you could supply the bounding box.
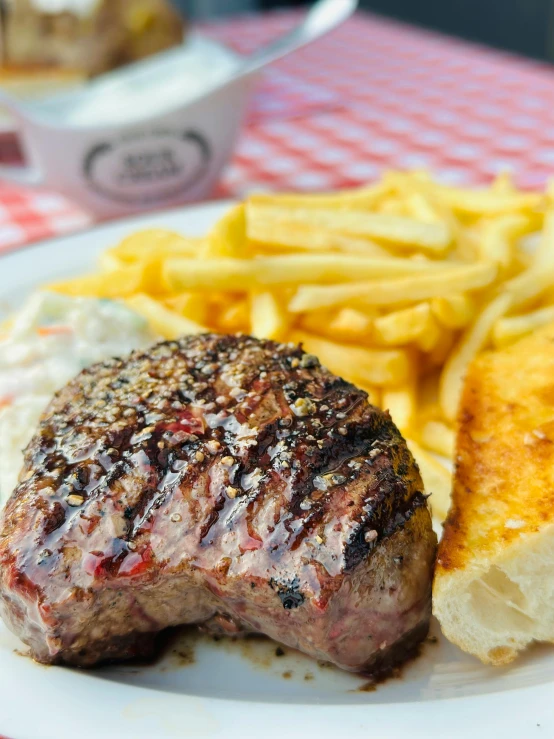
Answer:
[83,130,212,205]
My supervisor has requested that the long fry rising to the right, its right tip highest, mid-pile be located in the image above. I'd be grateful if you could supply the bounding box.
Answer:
[289,262,497,313]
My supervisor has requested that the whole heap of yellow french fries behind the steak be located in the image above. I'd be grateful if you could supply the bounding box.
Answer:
[50,172,554,520]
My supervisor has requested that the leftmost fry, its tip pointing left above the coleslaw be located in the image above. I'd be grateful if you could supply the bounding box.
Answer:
[47,265,144,298]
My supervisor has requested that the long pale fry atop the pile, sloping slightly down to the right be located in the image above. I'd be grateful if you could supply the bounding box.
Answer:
[246,201,450,254]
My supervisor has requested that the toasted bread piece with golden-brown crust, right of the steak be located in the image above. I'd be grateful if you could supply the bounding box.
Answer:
[433,325,554,665]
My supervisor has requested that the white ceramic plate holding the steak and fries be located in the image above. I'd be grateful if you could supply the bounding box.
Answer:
[0,203,554,739]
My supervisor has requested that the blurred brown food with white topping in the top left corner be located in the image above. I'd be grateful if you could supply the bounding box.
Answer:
[0,0,184,96]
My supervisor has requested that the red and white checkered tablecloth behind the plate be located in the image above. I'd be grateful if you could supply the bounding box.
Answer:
[0,7,554,251]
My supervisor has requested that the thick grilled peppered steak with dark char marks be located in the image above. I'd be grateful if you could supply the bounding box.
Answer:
[0,334,436,673]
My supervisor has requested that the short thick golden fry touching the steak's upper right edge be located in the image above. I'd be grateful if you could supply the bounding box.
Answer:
[290,331,413,386]
